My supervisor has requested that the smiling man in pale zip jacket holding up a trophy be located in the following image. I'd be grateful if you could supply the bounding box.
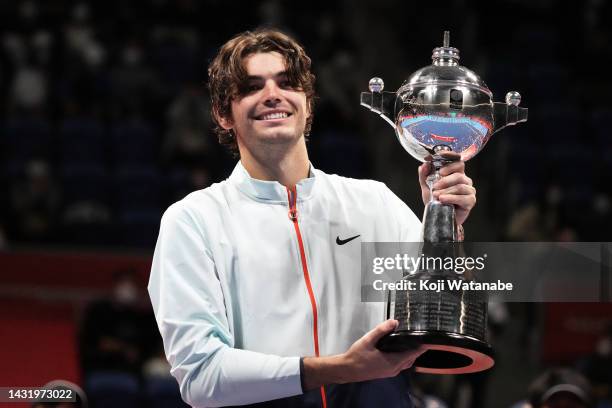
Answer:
[149,30,476,408]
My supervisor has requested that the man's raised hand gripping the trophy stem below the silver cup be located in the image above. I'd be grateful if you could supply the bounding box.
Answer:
[419,152,476,225]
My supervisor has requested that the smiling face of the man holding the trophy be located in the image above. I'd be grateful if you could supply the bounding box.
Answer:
[219,52,310,155]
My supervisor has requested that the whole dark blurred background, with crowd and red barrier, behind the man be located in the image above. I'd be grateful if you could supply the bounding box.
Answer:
[0,0,612,408]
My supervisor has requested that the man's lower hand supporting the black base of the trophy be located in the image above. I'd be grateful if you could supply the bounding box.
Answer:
[303,320,426,390]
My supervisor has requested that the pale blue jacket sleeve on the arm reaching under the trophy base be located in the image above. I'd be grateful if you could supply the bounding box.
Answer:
[148,202,302,407]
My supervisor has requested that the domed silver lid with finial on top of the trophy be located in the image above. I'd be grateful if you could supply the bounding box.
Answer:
[398,31,493,98]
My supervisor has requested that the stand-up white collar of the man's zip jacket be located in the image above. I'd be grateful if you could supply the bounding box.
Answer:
[229,161,317,204]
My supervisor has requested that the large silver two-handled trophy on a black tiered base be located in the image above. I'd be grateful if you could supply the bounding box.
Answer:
[361,31,527,374]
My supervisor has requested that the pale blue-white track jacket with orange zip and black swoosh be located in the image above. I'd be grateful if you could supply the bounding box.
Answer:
[148,163,421,407]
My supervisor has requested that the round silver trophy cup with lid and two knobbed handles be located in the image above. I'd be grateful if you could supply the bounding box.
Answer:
[361,31,527,162]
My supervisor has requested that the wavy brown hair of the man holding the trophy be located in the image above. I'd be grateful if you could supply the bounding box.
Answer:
[208,29,315,157]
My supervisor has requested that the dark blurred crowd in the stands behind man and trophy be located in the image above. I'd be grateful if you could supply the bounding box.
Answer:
[0,0,612,248]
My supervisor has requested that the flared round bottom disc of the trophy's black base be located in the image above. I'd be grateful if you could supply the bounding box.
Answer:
[376,330,495,374]
